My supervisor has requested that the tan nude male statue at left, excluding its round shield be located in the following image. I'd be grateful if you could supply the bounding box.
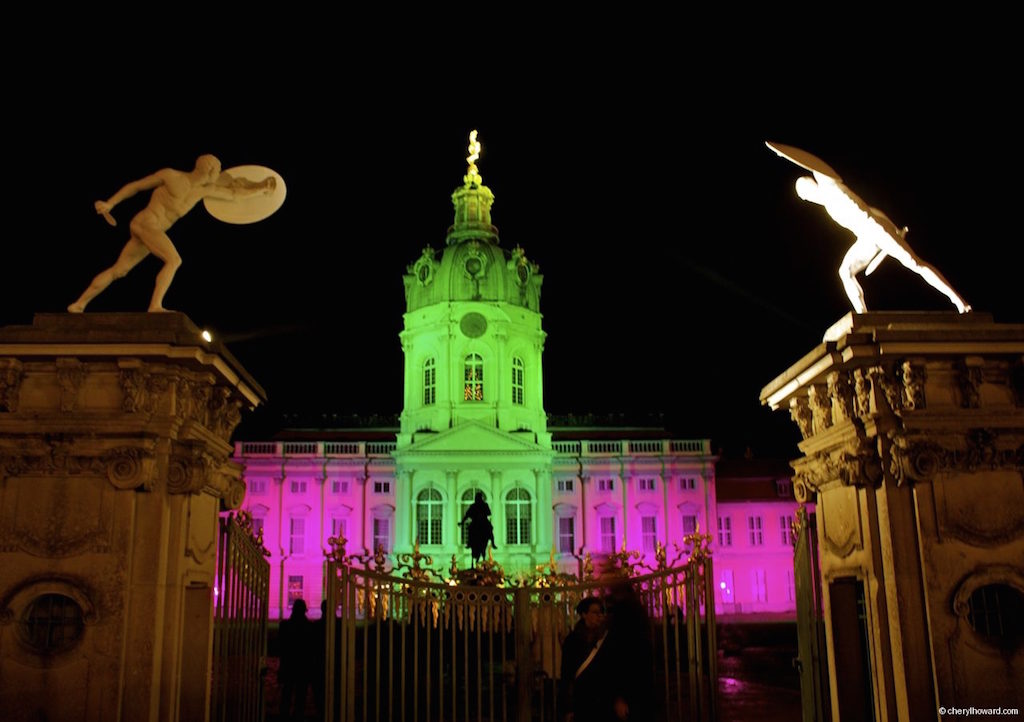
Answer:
[68,155,276,313]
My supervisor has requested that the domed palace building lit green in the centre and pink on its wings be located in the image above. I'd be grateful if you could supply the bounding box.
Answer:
[234,134,797,617]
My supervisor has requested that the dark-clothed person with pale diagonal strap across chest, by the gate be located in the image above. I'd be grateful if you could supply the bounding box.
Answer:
[558,597,620,722]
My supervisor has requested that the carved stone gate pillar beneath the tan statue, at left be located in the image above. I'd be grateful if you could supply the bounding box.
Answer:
[0,313,264,722]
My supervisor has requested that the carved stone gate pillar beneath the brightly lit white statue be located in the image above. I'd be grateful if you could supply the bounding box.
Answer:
[761,312,1024,722]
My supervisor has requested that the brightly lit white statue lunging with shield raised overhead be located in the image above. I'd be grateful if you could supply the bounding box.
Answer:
[768,142,971,313]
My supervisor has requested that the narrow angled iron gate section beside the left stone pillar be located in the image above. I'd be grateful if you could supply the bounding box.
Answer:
[210,512,270,722]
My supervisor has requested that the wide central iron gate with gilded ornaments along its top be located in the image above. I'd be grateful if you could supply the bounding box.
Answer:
[325,536,718,722]
